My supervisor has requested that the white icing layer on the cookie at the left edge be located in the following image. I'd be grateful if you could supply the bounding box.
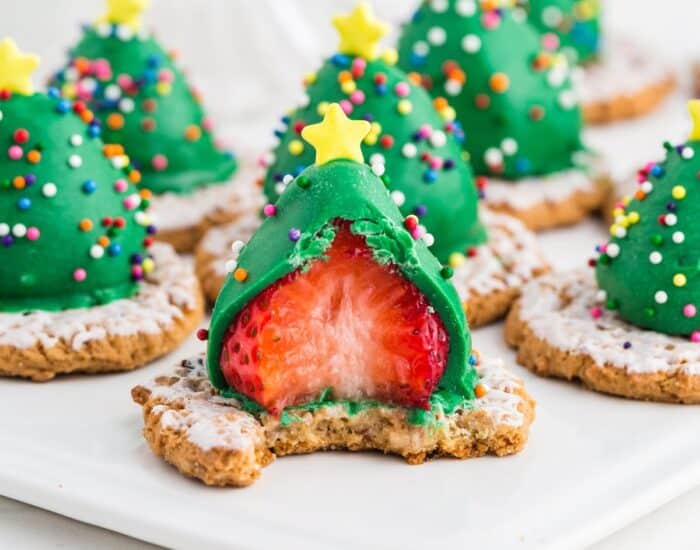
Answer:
[0,247,199,350]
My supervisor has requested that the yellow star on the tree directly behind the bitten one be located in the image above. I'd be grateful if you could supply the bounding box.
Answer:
[333,2,389,61]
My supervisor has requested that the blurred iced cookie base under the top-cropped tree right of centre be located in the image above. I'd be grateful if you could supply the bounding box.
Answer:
[485,170,611,232]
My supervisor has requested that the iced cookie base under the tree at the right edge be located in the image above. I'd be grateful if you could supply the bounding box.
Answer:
[504,270,700,404]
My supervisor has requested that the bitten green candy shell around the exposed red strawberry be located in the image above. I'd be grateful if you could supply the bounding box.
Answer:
[207,160,478,423]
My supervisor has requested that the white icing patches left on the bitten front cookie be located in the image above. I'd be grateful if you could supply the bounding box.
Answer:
[138,356,525,458]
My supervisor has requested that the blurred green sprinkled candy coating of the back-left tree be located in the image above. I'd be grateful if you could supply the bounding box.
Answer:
[54,26,236,193]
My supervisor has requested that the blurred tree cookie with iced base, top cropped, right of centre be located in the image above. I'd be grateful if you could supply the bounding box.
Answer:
[399,0,608,230]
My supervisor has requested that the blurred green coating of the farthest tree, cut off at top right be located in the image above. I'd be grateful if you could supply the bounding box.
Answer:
[529,0,601,64]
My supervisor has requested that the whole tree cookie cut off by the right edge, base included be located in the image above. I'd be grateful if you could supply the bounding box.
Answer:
[505,101,700,403]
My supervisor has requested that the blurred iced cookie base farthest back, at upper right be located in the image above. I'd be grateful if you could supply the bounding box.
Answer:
[579,37,677,124]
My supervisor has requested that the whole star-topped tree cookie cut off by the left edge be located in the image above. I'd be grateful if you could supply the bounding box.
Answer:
[0,39,203,380]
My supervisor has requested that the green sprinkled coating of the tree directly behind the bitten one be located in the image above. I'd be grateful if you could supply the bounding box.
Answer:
[264,54,486,262]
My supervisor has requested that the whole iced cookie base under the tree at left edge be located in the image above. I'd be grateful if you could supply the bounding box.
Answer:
[0,244,204,382]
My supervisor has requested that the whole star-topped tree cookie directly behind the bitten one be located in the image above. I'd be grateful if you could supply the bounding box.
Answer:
[197,4,547,324]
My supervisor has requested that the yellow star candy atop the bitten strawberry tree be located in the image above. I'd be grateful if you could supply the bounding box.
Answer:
[301,103,370,166]
